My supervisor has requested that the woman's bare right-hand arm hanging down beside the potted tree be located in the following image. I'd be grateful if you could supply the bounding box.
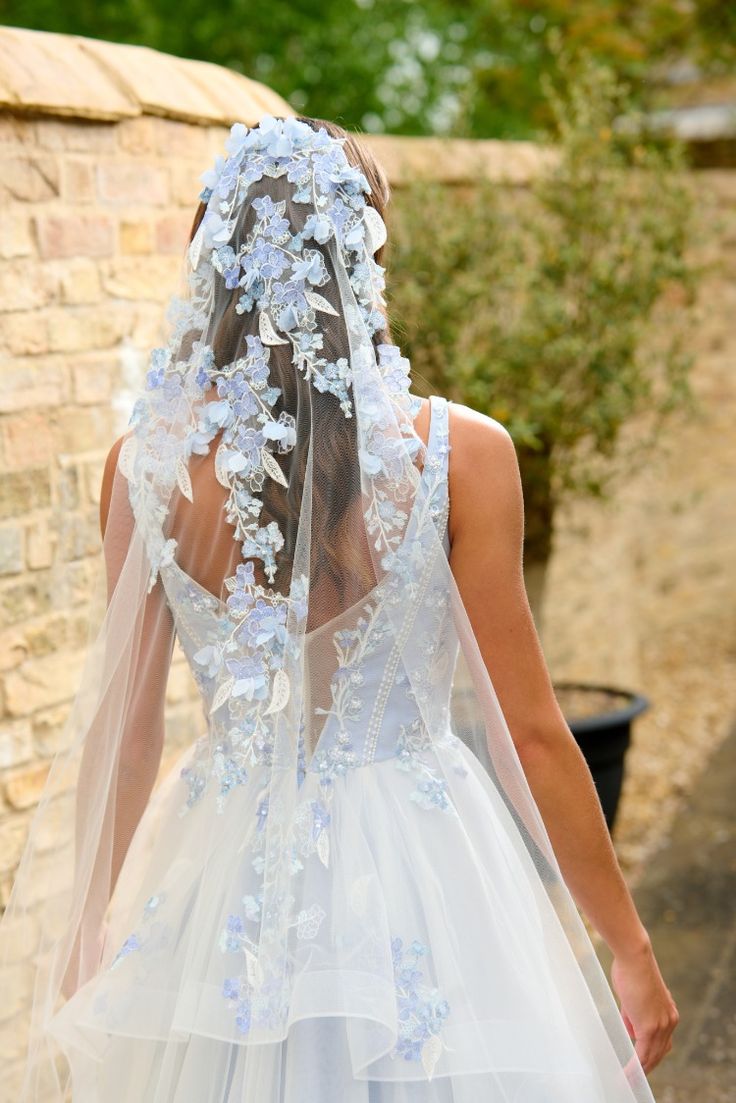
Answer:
[450,405,676,1068]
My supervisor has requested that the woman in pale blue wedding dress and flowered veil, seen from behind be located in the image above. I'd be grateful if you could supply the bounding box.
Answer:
[2,116,678,1103]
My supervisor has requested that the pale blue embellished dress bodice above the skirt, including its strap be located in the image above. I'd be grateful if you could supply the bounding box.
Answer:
[160,395,457,800]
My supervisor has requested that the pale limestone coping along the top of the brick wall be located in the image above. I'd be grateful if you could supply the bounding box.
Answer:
[0,26,555,186]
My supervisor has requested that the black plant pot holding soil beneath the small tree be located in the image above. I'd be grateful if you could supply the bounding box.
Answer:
[555,682,649,832]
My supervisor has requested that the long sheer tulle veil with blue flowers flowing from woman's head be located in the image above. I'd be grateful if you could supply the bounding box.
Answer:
[0,117,651,1103]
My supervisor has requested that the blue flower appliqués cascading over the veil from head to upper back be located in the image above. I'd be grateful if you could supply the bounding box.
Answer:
[131,116,419,600]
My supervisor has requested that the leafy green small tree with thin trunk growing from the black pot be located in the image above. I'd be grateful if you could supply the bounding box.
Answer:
[387,55,697,613]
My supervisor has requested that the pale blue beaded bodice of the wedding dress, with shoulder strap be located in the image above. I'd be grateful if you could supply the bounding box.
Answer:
[161,397,457,780]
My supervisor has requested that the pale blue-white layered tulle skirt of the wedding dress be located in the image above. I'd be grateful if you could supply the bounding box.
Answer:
[49,736,643,1103]
